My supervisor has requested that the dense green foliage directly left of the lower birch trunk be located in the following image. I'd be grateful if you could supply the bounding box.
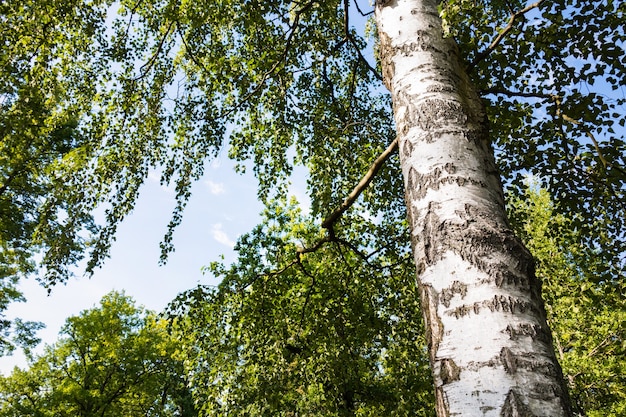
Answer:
[170,199,433,416]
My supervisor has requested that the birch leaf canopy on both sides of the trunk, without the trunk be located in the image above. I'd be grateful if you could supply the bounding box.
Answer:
[2,0,626,283]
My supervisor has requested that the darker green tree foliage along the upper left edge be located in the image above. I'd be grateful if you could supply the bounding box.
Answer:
[0,0,109,354]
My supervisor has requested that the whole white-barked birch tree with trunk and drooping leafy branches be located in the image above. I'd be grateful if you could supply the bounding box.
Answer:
[2,0,626,416]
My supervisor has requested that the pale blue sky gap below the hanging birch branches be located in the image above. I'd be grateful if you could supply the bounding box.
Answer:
[0,157,303,374]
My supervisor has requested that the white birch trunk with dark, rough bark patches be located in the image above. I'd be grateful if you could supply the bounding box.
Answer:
[376,0,571,417]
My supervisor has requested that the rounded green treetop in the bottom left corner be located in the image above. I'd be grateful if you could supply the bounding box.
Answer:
[0,293,196,417]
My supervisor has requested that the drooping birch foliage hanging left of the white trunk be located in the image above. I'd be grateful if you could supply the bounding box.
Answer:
[5,0,394,284]
